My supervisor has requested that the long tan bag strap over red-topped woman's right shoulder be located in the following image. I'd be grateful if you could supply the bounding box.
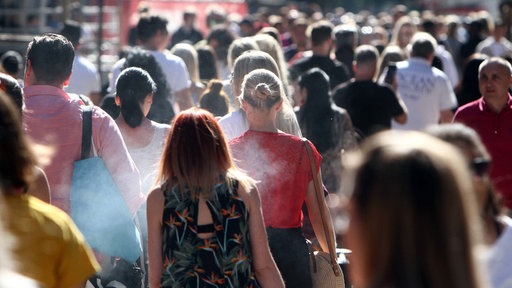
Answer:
[302,138,341,276]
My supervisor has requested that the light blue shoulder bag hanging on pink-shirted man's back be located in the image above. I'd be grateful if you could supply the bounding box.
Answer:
[70,106,142,263]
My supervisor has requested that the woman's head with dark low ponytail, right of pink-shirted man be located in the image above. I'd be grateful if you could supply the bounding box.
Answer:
[116,67,156,128]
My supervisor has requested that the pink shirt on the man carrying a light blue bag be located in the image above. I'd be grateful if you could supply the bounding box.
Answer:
[23,85,145,215]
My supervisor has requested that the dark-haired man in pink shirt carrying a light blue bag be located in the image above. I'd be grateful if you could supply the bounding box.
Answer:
[24,34,144,215]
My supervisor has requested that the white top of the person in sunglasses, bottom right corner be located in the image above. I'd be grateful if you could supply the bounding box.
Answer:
[486,217,512,288]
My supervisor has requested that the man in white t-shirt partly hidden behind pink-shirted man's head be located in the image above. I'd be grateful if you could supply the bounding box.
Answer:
[60,21,101,105]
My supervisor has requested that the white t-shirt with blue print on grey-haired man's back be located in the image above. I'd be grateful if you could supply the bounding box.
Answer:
[392,58,457,131]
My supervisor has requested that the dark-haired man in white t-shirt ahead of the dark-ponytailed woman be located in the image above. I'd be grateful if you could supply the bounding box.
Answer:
[109,16,193,112]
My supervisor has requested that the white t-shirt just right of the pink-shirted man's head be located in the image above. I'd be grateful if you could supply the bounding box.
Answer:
[64,53,101,96]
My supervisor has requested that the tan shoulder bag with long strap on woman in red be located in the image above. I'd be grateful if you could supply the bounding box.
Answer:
[302,138,345,288]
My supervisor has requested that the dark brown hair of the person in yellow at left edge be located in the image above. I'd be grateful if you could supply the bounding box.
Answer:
[0,91,36,193]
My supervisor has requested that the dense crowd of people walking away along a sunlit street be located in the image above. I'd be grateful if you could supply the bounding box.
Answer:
[0,5,512,288]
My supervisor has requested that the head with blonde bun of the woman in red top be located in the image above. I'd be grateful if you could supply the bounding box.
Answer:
[241,69,284,110]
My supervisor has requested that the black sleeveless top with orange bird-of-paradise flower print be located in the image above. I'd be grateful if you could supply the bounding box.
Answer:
[162,183,259,288]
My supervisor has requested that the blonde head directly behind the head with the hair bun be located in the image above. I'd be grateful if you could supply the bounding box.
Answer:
[231,50,281,96]
